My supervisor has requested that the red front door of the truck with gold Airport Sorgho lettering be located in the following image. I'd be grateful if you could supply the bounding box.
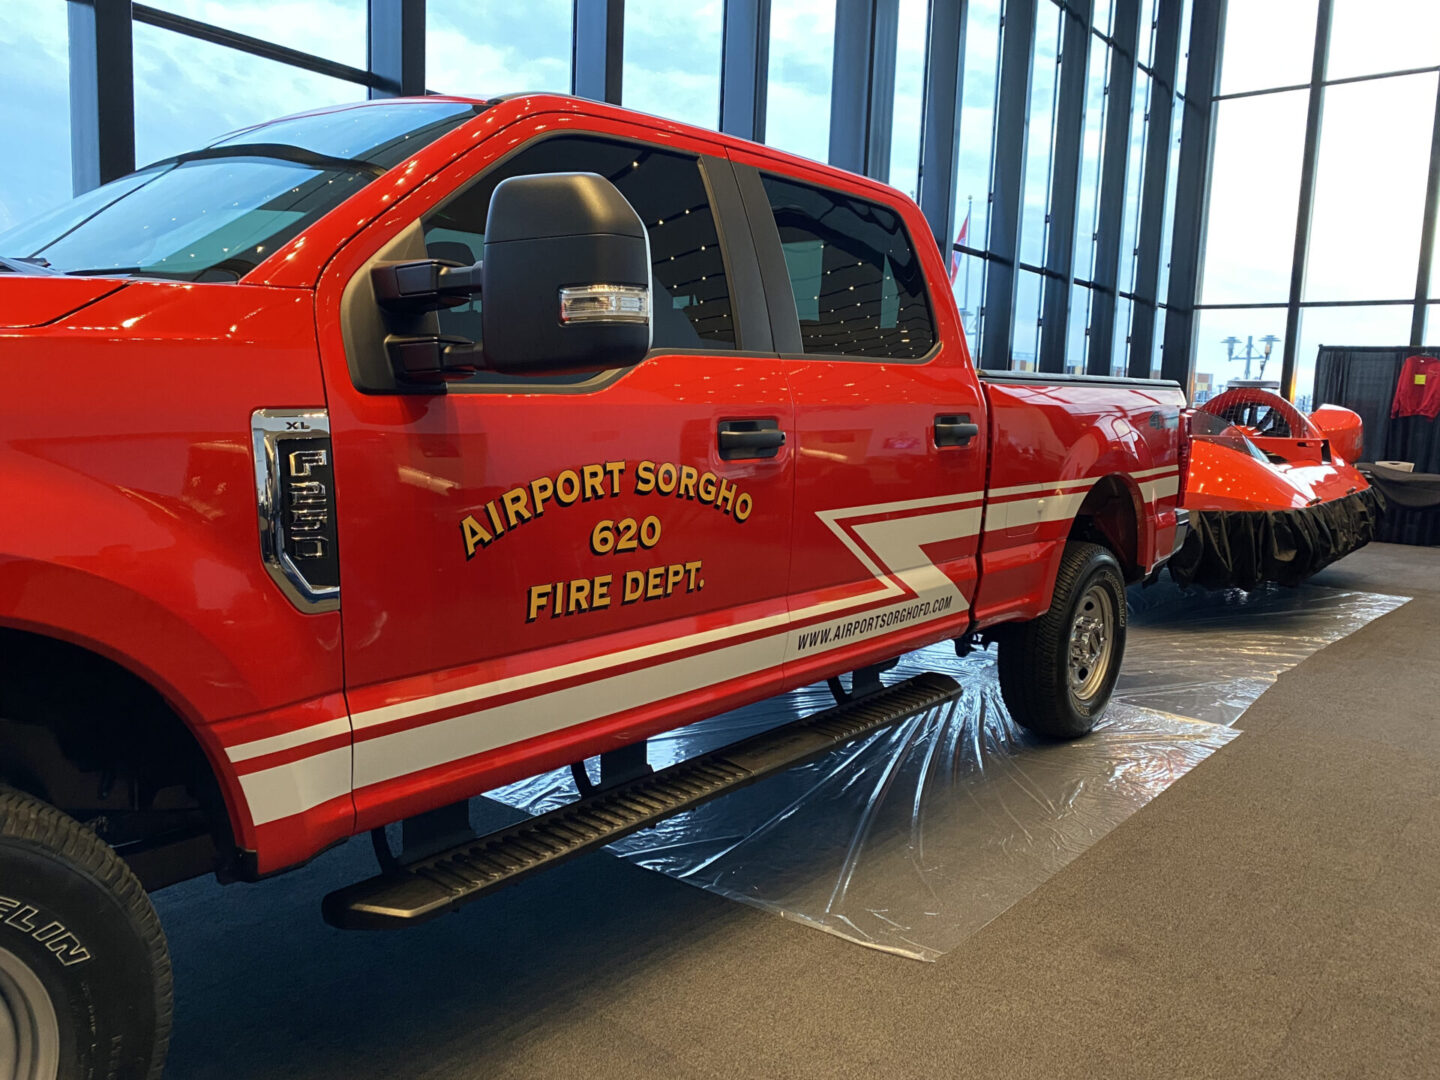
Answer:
[320,124,793,828]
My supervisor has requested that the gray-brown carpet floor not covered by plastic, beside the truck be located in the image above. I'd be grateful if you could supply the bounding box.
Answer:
[157,544,1440,1080]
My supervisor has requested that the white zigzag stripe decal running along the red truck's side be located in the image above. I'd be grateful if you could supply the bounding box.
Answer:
[229,465,1179,824]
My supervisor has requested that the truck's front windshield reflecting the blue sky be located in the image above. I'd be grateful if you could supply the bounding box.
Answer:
[0,101,482,281]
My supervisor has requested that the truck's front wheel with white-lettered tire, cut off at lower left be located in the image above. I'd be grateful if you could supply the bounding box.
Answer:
[0,788,171,1080]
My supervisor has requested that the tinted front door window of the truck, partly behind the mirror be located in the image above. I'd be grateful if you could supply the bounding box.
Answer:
[422,135,734,348]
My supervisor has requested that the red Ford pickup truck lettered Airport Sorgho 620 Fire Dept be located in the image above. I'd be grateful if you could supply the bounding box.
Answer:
[0,95,1184,1080]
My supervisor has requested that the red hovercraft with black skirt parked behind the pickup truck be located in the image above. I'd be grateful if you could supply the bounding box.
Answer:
[1169,384,1385,589]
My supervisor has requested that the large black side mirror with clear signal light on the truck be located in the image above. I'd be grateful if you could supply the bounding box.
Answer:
[481,173,651,374]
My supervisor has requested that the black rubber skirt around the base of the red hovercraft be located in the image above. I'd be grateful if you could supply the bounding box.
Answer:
[1169,487,1385,589]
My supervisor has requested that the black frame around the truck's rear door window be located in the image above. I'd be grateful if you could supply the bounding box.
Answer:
[733,161,945,364]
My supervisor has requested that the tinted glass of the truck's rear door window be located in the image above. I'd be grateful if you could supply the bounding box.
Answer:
[762,176,935,360]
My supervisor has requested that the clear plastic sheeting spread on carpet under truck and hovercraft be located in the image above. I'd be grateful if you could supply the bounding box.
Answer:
[491,585,1404,960]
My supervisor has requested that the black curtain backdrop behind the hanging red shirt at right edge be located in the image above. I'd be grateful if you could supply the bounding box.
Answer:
[1313,346,1440,544]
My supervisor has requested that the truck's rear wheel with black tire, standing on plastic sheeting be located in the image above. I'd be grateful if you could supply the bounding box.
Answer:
[999,543,1125,739]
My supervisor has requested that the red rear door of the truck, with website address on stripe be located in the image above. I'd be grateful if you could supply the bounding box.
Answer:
[737,156,986,683]
